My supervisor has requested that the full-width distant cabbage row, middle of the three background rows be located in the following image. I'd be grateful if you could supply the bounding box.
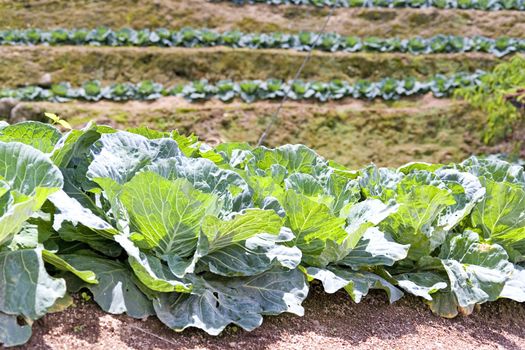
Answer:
[0,27,525,57]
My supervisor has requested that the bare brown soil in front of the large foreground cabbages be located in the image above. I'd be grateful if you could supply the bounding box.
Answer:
[14,286,525,350]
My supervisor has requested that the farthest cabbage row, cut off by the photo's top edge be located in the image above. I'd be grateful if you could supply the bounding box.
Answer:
[211,0,525,11]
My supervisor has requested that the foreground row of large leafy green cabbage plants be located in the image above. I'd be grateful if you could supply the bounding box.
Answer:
[0,121,525,346]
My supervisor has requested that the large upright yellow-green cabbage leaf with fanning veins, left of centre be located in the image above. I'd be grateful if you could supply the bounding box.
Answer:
[120,172,217,258]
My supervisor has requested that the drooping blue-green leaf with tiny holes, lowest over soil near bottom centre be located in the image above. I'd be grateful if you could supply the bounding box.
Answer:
[154,269,308,335]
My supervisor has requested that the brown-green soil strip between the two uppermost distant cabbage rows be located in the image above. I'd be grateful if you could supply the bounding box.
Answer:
[0,0,525,37]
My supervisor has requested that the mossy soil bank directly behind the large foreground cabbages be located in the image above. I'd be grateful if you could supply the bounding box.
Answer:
[12,98,483,167]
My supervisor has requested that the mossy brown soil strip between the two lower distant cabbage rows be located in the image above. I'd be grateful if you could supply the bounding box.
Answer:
[0,46,501,86]
